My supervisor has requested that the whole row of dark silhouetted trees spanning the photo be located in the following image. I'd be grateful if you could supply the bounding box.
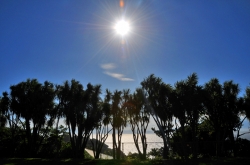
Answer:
[0,73,250,159]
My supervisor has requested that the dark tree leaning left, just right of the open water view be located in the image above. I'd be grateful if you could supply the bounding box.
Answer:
[141,74,173,159]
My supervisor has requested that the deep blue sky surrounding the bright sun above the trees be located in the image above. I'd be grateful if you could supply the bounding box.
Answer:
[0,0,250,137]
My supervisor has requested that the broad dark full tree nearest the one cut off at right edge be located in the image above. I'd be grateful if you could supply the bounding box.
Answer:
[204,78,243,156]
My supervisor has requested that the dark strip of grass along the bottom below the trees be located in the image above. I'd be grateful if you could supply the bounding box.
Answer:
[0,158,250,165]
